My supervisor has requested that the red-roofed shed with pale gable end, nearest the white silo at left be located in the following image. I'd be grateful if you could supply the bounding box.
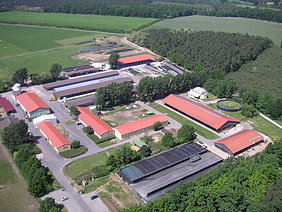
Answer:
[16,93,51,119]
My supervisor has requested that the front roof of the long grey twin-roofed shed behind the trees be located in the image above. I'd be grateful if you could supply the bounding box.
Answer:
[54,77,133,99]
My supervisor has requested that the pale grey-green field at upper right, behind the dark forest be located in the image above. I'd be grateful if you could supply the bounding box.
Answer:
[149,15,282,46]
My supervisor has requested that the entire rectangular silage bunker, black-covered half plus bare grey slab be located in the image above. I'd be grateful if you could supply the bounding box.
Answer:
[117,143,222,201]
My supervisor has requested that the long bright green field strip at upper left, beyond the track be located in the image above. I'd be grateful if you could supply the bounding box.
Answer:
[0,11,157,32]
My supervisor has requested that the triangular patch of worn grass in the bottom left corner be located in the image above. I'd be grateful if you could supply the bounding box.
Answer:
[0,144,39,212]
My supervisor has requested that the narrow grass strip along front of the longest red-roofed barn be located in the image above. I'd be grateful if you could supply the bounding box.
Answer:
[149,103,218,139]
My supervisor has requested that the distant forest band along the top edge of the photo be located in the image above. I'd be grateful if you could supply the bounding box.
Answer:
[0,0,282,23]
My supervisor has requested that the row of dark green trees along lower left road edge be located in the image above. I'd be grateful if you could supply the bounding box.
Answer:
[2,120,53,197]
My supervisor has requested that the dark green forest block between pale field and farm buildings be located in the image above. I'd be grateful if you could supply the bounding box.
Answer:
[130,29,271,73]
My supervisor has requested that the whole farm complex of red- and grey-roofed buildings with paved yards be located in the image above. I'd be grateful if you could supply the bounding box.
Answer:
[0,36,274,212]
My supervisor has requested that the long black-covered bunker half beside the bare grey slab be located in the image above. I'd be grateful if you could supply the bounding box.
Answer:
[119,143,207,182]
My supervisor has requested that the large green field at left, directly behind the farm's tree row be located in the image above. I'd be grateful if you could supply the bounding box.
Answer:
[0,24,110,79]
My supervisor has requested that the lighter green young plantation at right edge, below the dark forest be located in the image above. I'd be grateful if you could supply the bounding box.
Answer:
[227,46,282,99]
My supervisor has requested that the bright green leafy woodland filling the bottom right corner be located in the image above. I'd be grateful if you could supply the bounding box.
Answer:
[123,140,282,212]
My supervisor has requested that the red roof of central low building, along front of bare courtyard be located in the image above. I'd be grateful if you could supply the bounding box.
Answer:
[115,115,168,135]
